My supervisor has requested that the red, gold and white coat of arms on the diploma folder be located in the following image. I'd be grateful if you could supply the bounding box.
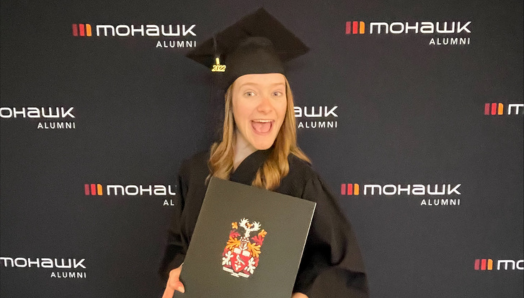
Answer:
[222,218,267,278]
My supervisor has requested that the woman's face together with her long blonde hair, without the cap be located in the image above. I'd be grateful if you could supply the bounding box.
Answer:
[209,73,309,189]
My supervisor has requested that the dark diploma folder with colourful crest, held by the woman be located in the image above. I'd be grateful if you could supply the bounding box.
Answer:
[174,178,316,298]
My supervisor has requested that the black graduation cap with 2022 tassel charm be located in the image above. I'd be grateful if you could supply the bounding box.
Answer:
[186,8,309,89]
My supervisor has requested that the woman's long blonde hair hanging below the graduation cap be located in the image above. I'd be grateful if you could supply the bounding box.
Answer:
[208,78,311,190]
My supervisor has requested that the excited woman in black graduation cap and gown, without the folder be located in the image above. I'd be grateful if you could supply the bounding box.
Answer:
[160,10,367,298]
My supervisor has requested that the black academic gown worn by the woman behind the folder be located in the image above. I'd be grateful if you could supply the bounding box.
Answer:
[159,150,368,298]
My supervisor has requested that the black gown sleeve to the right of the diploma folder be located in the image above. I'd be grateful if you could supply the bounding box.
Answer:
[293,176,368,298]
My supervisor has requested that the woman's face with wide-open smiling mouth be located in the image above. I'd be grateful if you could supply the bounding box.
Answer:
[233,73,287,150]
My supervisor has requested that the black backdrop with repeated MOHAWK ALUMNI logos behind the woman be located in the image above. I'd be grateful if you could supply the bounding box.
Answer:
[0,0,524,298]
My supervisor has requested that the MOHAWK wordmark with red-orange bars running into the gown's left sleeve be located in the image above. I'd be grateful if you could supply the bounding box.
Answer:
[84,184,176,196]
